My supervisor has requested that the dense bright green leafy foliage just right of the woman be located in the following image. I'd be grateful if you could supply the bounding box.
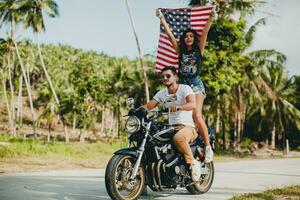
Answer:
[201,18,249,94]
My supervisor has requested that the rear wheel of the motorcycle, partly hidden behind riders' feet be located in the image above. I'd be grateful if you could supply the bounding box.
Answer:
[186,162,215,194]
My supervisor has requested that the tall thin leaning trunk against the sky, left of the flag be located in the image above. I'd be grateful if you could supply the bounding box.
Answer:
[126,0,150,102]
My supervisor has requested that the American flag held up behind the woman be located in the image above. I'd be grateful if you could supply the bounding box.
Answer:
[155,6,214,72]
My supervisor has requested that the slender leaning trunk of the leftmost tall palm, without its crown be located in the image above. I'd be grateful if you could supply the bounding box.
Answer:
[13,39,36,137]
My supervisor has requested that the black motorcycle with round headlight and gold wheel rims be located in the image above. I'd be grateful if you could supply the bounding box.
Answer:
[105,100,215,200]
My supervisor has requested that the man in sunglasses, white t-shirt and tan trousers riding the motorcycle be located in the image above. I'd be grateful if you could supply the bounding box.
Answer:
[142,66,201,181]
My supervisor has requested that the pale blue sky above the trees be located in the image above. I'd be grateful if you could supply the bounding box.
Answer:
[0,0,300,76]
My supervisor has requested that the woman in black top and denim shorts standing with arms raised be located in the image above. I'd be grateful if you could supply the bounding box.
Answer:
[156,5,215,162]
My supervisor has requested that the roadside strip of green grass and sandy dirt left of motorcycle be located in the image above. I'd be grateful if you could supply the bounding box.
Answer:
[0,134,126,173]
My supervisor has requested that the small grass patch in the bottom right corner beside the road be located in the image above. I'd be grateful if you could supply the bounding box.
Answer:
[230,185,300,200]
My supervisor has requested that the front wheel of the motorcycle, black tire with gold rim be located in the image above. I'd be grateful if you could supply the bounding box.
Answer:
[105,155,145,200]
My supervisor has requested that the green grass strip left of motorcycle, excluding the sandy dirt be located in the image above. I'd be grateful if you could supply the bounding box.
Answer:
[0,134,126,159]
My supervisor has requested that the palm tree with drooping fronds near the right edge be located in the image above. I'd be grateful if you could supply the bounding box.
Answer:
[250,50,300,148]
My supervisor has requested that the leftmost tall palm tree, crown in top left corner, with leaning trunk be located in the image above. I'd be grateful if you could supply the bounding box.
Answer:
[0,0,35,135]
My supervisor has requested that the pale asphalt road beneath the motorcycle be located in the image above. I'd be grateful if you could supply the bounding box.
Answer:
[0,159,300,200]
